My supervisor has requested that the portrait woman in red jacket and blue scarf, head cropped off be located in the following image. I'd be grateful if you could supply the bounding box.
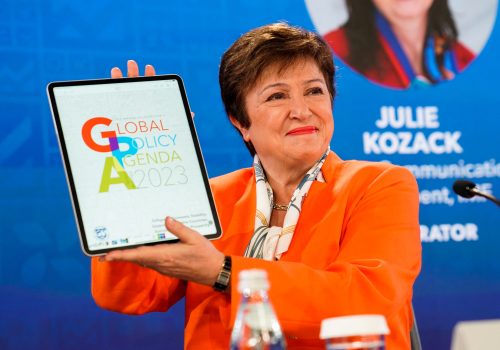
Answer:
[325,0,475,89]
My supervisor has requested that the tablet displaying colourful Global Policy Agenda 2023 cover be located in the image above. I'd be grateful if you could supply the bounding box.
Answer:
[47,75,221,256]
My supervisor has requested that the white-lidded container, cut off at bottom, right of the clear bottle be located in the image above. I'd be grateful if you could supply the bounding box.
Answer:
[320,315,389,350]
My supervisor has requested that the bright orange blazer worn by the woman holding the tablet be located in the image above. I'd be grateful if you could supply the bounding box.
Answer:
[92,152,421,350]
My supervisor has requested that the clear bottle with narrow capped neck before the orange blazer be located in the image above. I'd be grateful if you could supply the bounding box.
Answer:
[231,269,286,350]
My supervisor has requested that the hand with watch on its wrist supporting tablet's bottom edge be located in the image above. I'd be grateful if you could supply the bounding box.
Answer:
[104,217,224,286]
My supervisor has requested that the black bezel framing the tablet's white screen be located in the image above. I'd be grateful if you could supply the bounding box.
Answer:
[47,74,222,256]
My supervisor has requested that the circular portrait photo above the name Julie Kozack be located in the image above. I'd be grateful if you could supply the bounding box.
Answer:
[305,0,498,89]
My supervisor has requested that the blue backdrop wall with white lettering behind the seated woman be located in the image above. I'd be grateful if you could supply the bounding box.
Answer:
[0,0,500,350]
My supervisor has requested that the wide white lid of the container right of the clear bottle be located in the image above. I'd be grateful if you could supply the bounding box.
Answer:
[319,315,389,339]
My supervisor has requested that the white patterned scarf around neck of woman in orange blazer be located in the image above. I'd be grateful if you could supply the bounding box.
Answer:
[245,148,330,260]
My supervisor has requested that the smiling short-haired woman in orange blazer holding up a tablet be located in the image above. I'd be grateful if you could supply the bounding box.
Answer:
[92,23,421,349]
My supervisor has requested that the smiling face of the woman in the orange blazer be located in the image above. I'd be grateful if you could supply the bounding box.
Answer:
[237,59,333,171]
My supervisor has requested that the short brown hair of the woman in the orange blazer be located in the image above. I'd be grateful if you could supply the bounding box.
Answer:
[219,23,335,156]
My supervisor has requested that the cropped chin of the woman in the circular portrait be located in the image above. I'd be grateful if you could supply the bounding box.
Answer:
[372,0,434,22]
